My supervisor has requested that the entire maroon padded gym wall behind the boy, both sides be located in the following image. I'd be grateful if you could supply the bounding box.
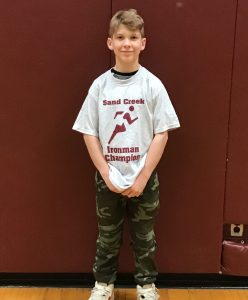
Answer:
[0,0,248,273]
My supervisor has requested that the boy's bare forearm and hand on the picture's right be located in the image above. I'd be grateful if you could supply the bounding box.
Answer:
[122,131,168,198]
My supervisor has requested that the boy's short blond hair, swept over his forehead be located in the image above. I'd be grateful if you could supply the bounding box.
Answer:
[109,8,145,37]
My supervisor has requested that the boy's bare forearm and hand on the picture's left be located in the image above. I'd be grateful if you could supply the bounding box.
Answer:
[84,134,121,193]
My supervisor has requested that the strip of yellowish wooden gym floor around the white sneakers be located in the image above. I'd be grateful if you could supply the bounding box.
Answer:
[0,287,248,300]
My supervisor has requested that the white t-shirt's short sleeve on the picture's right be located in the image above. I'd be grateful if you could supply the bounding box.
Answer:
[153,86,180,134]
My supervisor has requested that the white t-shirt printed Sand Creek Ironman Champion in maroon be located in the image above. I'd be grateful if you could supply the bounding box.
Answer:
[73,66,180,191]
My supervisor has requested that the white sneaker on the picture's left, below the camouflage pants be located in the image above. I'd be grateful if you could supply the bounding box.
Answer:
[89,281,114,300]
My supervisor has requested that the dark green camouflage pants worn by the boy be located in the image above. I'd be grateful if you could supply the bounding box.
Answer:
[93,172,159,285]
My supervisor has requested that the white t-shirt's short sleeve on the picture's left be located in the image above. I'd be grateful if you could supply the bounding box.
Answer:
[72,82,99,136]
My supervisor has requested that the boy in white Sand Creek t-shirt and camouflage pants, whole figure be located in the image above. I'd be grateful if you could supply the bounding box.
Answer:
[73,9,180,300]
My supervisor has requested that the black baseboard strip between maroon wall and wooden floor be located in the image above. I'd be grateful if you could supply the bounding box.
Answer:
[0,273,248,288]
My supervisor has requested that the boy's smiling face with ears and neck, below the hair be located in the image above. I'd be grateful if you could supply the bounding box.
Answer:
[107,24,146,68]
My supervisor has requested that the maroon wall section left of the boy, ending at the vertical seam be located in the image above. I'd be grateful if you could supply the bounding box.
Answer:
[0,0,111,272]
